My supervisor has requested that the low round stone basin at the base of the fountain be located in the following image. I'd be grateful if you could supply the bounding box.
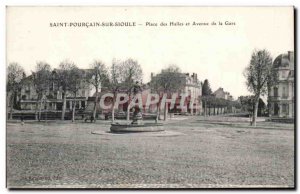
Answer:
[110,123,164,133]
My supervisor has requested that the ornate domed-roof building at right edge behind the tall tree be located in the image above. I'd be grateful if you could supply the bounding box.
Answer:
[269,51,295,118]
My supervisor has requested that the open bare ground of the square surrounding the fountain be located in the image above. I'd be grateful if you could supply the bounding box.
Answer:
[6,116,294,188]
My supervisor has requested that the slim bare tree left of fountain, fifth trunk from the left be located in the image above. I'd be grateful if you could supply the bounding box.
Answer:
[86,60,109,121]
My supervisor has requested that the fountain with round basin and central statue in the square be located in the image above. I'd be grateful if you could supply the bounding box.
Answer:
[110,82,164,133]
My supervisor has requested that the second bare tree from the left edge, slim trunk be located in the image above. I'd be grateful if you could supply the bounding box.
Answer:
[32,62,51,121]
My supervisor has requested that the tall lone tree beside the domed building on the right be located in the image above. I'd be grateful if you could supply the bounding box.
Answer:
[244,50,274,126]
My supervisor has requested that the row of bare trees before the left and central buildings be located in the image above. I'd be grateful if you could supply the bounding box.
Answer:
[7,59,188,121]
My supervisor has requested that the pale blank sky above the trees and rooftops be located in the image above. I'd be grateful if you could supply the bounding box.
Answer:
[6,6,294,99]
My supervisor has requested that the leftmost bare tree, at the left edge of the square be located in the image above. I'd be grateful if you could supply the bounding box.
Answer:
[6,63,25,119]
